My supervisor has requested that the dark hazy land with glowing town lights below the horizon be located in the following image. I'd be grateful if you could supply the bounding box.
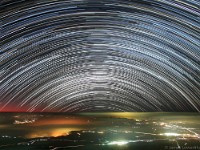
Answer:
[0,113,200,150]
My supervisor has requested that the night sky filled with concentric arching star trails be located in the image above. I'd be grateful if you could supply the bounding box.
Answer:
[0,0,200,112]
